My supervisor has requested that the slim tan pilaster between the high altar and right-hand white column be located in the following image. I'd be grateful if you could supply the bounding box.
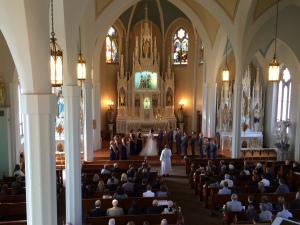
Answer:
[192,39,199,131]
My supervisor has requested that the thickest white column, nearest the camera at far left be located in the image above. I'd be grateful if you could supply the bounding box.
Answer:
[21,94,57,225]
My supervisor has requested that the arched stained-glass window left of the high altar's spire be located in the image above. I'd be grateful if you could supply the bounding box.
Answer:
[105,27,119,63]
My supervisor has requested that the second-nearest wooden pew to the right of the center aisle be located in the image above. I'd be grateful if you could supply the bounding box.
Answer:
[209,192,296,215]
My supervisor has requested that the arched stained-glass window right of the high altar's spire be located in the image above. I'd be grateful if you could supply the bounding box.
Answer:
[173,28,189,64]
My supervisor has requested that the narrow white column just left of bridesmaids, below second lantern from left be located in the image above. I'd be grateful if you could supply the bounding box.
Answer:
[82,82,94,161]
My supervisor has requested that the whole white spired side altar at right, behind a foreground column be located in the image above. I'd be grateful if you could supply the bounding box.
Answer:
[217,66,265,149]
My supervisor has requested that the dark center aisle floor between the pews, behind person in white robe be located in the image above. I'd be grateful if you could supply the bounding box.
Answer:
[159,166,222,225]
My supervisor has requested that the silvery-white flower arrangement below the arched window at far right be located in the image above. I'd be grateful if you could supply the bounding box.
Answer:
[274,120,292,151]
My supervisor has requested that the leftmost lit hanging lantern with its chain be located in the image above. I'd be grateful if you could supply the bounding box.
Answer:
[50,0,63,87]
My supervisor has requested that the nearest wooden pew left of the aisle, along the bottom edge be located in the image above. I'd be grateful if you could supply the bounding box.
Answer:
[86,214,178,225]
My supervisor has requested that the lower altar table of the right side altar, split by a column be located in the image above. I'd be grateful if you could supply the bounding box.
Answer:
[219,131,263,150]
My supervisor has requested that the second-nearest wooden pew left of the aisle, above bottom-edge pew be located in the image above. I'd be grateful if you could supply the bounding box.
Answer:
[82,197,169,211]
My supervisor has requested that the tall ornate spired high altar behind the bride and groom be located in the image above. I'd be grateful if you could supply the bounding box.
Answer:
[116,7,177,133]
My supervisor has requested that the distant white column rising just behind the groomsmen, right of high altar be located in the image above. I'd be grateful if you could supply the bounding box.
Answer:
[206,83,217,137]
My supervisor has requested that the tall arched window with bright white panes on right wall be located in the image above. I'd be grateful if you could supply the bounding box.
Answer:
[276,68,292,121]
